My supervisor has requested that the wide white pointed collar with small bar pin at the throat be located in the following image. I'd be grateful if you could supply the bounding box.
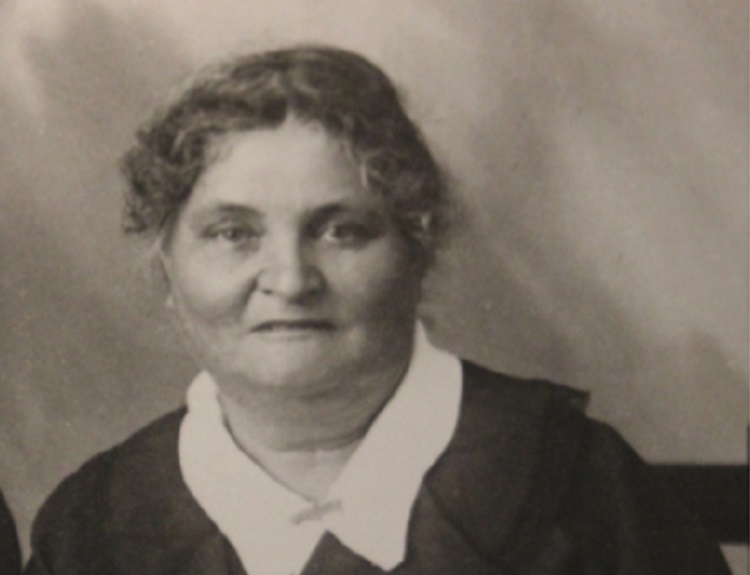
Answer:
[179,327,462,575]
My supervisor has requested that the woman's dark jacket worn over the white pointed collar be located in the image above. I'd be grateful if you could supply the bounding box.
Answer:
[26,363,729,575]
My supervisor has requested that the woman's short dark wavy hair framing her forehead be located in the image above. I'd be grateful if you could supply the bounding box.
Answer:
[120,46,448,267]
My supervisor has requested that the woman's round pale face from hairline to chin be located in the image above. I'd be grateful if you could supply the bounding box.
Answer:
[162,120,420,393]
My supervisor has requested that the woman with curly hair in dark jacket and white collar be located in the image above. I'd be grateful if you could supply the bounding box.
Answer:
[27,47,727,575]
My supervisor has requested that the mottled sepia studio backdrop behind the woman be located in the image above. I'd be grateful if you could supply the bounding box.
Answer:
[0,0,748,569]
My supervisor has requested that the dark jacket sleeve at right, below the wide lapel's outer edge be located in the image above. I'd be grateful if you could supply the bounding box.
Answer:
[561,422,730,575]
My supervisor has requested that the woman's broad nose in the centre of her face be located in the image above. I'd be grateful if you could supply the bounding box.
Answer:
[257,241,324,302]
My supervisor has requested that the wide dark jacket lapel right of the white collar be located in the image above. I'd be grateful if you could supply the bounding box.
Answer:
[396,362,586,575]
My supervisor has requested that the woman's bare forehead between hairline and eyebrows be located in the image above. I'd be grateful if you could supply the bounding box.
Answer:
[186,120,380,216]
